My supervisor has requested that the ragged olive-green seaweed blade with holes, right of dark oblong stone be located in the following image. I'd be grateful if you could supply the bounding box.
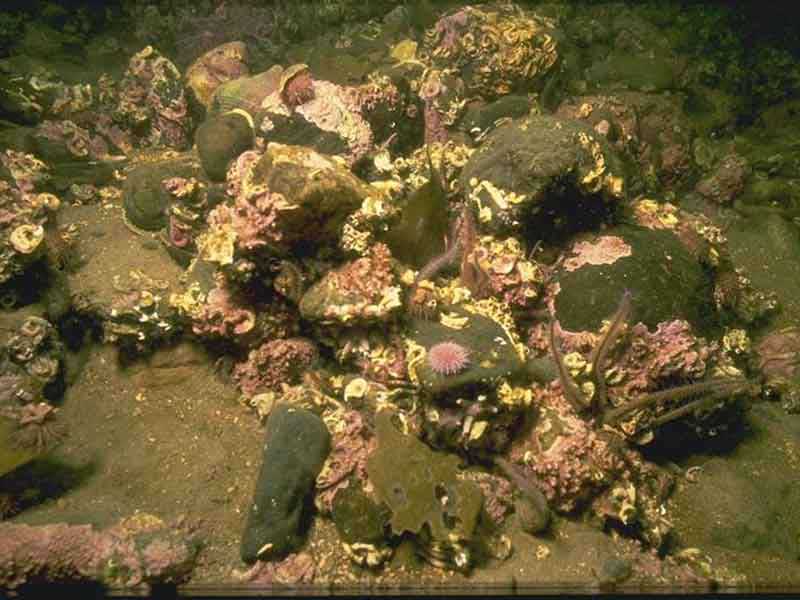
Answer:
[367,410,483,541]
